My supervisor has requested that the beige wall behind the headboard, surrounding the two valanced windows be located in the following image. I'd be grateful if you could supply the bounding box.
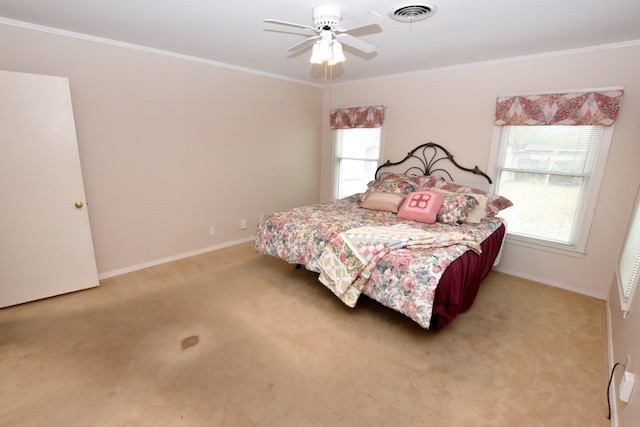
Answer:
[321,46,640,299]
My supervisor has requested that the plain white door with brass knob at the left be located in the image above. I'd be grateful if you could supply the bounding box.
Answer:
[0,71,98,307]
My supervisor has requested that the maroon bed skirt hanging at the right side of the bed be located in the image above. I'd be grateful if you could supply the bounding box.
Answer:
[429,224,505,329]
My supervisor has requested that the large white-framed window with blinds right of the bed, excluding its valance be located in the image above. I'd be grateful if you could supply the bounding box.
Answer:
[494,126,611,253]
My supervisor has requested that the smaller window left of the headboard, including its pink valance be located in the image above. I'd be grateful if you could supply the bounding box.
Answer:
[330,105,385,199]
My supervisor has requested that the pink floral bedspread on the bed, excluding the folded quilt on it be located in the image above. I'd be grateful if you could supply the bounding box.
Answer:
[255,195,502,328]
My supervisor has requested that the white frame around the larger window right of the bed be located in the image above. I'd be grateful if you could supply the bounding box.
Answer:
[489,125,614,258]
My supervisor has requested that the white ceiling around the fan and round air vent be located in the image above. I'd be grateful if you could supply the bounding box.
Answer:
[0,0,640,85]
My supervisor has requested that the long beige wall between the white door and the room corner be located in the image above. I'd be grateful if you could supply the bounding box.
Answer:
[0,25,322,277]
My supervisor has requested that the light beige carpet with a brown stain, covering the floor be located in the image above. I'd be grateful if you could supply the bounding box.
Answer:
[0,243,609,426]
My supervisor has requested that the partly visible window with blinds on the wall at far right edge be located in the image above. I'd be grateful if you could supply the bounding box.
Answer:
[616,193,640,317]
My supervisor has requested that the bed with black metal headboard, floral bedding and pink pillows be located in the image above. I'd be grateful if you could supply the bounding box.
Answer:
[255,142,511,329]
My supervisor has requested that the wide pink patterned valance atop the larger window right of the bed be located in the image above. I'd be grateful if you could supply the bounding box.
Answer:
[495,90,623,126]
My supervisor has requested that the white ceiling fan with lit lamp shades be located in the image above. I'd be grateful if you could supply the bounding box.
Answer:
[264,5,382,65]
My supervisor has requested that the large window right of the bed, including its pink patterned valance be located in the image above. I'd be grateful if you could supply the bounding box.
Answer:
[491,88,623,256]
